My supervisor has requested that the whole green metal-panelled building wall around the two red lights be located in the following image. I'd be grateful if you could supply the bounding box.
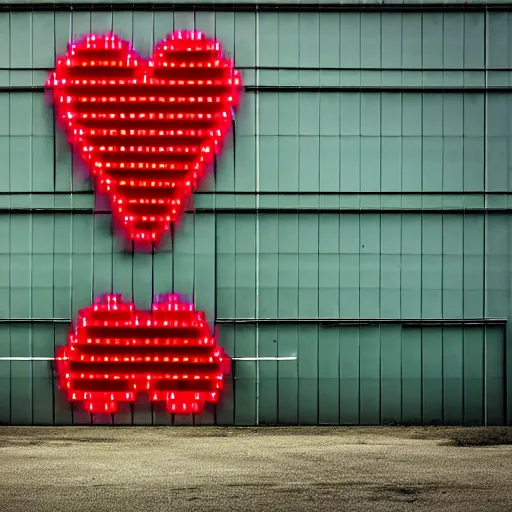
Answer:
[0,0,512,425]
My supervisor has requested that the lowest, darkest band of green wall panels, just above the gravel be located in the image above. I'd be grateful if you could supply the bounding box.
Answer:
[0,324,505,425]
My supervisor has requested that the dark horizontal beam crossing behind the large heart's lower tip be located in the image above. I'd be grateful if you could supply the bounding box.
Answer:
[0,206,512,215]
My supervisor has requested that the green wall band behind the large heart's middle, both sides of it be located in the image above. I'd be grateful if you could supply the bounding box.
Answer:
[0,93,496,195]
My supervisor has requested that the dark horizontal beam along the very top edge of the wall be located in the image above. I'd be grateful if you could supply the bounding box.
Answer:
[0,1,512,13]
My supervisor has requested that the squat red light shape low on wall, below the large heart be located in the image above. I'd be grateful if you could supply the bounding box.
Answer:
[55,295,231,414]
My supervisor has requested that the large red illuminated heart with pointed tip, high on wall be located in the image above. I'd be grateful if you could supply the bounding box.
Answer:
[46,31,241,242]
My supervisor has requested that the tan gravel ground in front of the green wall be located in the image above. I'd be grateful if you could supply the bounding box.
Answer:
[0,427,512,512]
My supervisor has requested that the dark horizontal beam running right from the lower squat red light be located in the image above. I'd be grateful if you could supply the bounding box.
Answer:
[216,318,507,327]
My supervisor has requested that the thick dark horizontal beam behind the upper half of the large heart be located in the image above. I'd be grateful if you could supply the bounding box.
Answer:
[0,85,512,94]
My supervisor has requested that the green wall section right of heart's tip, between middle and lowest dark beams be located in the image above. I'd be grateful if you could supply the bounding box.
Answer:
[213,213,492,319]
